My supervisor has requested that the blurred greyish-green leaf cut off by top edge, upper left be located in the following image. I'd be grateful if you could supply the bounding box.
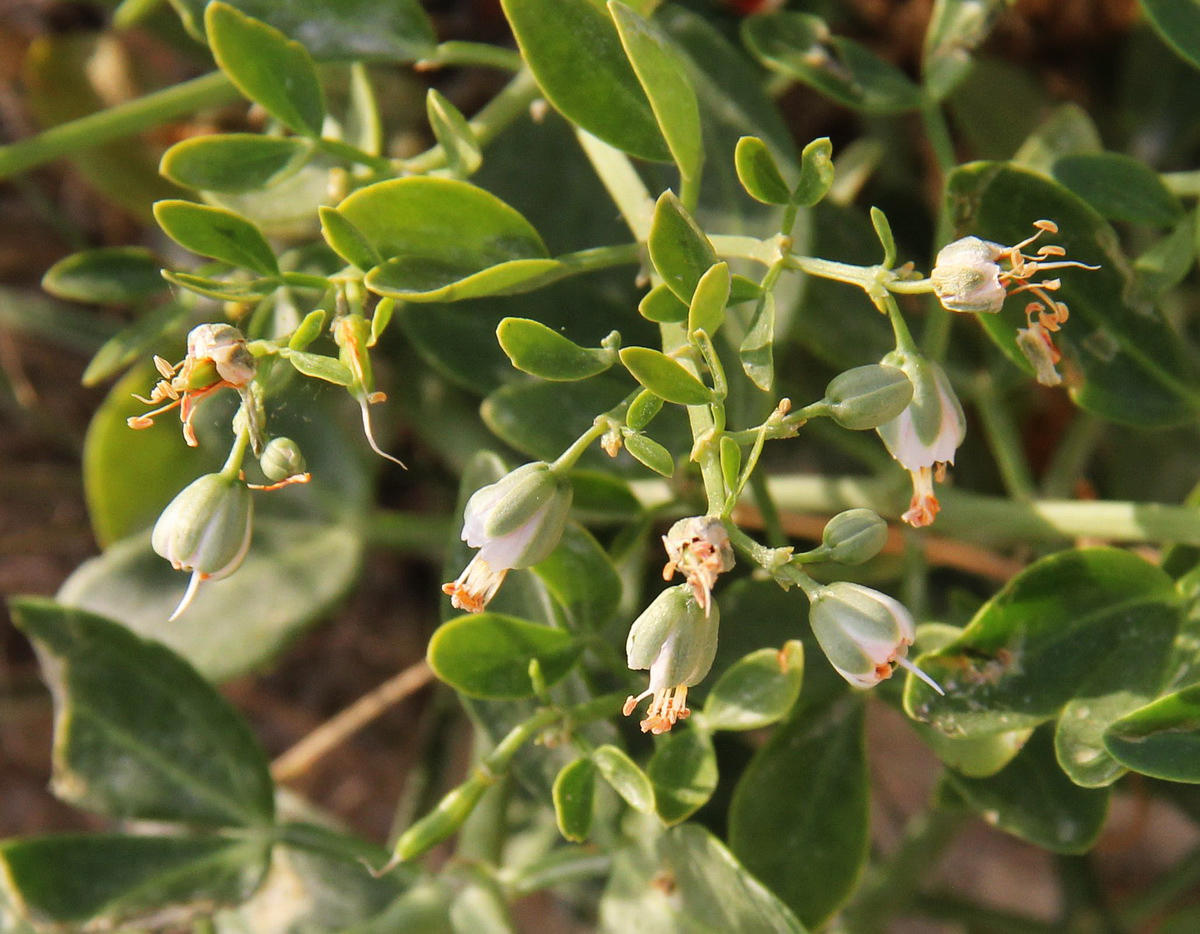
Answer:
[170,0,437,61]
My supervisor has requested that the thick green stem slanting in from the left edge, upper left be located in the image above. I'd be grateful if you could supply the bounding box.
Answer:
[0,71,238,179]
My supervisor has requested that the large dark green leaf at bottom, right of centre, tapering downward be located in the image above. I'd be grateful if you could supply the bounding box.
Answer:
[730,697,870,927]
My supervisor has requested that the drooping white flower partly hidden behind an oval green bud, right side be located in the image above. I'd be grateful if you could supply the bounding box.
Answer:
[876,351,966,528]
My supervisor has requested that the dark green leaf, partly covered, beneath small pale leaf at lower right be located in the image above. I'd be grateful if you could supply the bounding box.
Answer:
[947,730,1110,852]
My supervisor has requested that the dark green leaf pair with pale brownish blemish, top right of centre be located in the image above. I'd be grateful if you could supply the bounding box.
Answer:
[742,12,922,114]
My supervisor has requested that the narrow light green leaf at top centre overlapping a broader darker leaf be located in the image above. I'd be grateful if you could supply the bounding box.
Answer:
[608,0,704,179]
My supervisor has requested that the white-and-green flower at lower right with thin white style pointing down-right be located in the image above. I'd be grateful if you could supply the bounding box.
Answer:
[809,581,943,694]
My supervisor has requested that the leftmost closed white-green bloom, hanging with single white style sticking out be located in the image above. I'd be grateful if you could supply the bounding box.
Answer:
[150,473,254,619]
